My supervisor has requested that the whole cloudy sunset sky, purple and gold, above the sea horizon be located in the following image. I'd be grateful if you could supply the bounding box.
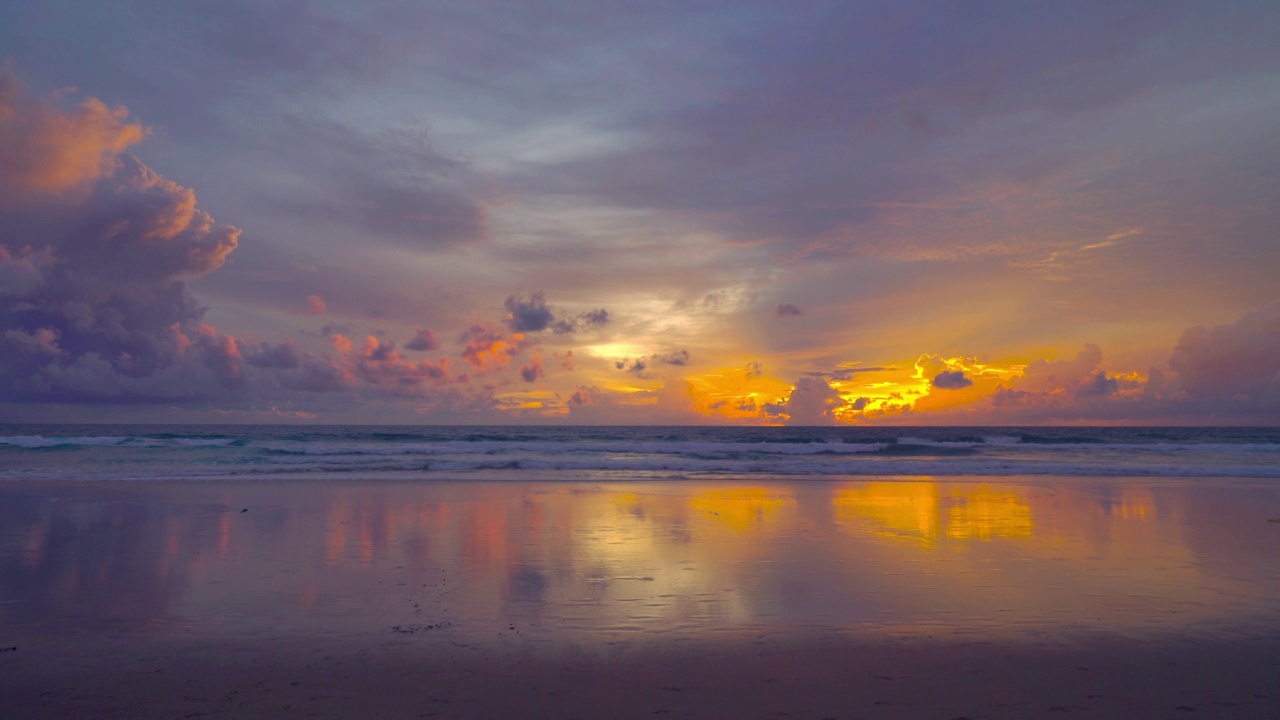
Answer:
[0,0,1280,425]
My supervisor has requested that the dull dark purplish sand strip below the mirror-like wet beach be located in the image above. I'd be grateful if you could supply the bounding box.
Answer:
[0,627,1280,720]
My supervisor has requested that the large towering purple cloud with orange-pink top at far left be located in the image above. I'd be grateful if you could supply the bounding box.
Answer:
[0,78,243,402]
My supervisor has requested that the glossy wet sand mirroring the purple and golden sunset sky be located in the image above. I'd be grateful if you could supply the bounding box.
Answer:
[0,480,1280,644]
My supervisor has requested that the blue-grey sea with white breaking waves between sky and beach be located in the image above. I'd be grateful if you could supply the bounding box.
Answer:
[0,425,1280,482]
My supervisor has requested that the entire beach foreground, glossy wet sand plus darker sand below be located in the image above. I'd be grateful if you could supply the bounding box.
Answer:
[0,479,1280,720]
